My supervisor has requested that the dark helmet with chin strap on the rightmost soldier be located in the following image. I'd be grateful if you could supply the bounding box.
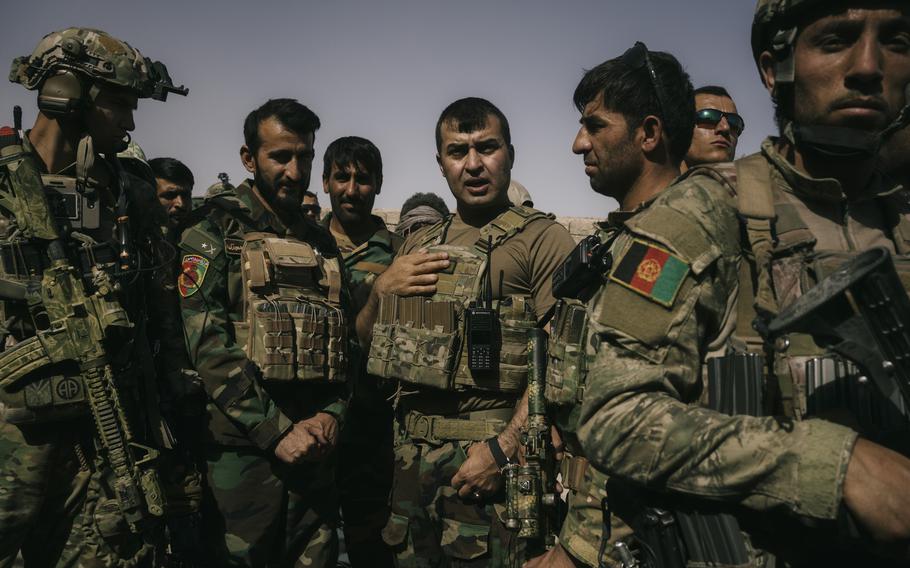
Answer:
[752,0,910,158]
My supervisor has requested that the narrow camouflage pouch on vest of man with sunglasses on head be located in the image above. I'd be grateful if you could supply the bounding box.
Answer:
[546,299,587,404]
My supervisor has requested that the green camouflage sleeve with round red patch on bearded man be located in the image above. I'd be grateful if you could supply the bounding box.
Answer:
[177,220,292,449]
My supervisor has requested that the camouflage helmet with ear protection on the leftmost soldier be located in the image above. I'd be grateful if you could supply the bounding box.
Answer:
[9,28,188,115]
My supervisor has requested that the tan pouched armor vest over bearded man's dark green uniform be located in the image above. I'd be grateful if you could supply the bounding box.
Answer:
[234,232,350,382]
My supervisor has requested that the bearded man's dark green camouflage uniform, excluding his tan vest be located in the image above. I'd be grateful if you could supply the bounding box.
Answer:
[179,180,353,566]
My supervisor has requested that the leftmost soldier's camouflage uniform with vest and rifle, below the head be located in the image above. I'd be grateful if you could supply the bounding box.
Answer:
[0,128,180,566]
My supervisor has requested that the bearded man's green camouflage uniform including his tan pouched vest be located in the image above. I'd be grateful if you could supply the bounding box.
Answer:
[178,181,356,566]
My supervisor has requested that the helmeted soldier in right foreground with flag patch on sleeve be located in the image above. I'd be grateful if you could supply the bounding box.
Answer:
[566,0,910,566]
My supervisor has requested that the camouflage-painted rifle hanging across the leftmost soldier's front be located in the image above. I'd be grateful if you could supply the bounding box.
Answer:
[0,127,164,533]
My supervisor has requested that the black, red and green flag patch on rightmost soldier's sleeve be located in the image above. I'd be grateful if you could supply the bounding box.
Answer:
[610,240,689,308]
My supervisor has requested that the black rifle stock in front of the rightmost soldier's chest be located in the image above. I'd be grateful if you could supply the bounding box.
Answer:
[768,247,910,424]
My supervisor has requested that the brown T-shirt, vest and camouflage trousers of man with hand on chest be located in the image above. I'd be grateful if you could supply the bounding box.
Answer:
[367,207,573,566]
